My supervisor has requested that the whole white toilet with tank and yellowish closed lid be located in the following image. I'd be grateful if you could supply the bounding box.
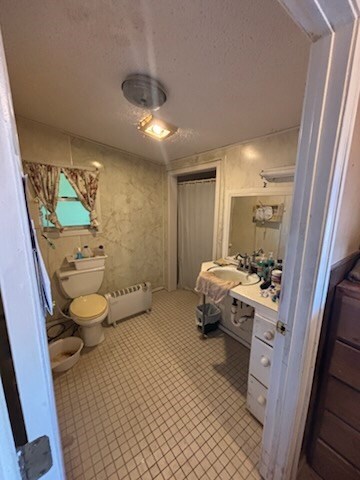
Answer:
[56,266,108,347]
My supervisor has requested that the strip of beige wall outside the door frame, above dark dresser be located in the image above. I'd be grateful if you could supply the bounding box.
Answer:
[332,104,360,264]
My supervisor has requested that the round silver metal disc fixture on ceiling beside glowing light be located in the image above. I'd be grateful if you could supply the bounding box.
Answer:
[121,73,166,110]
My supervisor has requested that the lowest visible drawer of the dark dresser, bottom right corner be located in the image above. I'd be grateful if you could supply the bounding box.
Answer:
[311,439,360,480]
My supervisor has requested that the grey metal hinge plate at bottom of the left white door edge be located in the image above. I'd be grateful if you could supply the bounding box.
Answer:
[17,435,52,480]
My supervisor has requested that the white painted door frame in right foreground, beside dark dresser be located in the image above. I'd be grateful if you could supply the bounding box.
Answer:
[260,0,360,480]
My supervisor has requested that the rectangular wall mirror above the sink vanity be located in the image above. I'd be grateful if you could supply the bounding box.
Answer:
[228,192,292,260]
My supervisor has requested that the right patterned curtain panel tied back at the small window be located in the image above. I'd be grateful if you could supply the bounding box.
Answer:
[61,168,99,230]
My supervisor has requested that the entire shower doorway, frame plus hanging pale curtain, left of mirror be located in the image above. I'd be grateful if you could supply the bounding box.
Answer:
[166,159,222,291]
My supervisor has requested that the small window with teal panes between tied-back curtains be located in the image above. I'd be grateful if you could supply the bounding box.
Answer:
[40,173,90,230]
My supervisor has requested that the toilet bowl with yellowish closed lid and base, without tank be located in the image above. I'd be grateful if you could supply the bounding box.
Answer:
[69,293,109,347]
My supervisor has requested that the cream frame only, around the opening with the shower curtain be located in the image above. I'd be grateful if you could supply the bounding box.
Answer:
[165,159,223,292]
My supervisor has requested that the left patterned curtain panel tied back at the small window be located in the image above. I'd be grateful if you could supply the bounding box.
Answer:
[24,162,63,231]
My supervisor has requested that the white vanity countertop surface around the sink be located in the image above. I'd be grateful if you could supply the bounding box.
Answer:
[201,262,279,321]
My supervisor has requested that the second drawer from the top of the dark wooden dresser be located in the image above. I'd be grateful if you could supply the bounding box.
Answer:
[330,340,360,390]
